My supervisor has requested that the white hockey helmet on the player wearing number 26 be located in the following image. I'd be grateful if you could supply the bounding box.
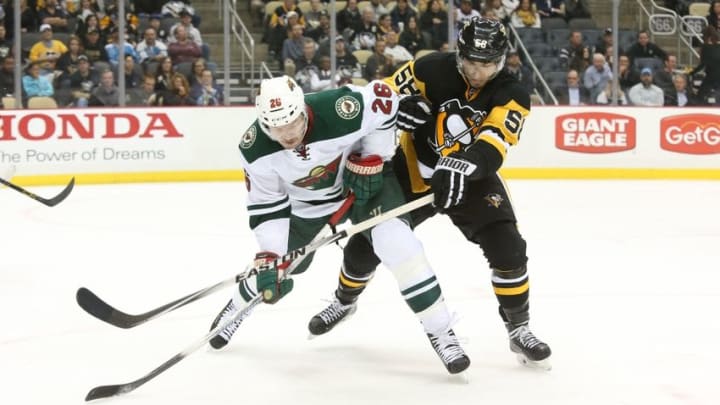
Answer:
[255,76,307,135]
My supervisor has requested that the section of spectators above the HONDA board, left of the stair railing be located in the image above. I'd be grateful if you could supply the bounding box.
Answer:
[0,0,223,108]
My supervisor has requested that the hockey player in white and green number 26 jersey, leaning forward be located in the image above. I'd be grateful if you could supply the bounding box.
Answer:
[210,76,470,374]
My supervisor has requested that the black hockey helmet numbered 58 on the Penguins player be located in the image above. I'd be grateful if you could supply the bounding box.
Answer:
[457,17,508,63]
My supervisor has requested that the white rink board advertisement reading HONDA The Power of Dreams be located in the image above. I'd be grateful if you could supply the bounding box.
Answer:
[0,108,254,174]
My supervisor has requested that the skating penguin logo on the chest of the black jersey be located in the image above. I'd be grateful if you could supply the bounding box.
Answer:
[429,99,487,156]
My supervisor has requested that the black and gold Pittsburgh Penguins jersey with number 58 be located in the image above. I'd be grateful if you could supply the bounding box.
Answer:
[386,52,530,191]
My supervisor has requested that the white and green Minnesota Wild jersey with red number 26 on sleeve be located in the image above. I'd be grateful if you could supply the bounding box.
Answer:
[240,81,398,231]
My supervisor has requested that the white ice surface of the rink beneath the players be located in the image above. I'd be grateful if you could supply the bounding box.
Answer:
[0,181,720,405]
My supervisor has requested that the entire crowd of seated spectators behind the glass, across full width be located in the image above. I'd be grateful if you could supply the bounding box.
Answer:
[0,0,720,107]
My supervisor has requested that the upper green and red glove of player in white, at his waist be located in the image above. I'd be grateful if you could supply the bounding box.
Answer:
[343,154,384,205]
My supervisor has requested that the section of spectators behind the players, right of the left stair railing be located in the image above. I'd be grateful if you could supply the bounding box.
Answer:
[253,0,720,106]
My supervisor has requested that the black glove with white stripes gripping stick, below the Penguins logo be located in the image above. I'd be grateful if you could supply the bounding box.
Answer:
[430,152,485,213]
